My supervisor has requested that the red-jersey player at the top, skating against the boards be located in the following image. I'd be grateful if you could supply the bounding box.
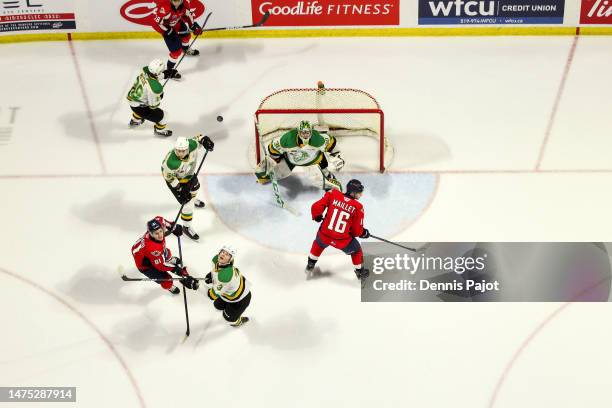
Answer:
[153,0,202,80]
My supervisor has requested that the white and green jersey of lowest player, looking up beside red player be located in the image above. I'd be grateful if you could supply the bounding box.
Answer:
[208,255,251,303]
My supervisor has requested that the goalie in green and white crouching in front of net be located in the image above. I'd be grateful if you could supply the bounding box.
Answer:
[255,120,344,191]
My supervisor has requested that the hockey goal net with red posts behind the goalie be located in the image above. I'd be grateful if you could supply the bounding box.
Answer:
[255,88,393,173]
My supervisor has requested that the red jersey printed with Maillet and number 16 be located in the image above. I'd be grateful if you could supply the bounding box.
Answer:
[310,189,364,247]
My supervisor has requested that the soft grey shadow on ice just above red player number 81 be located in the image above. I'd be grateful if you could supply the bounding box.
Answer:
[72,190,176,233]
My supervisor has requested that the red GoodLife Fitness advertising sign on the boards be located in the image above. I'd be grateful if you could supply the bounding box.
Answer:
[251,0,400,27]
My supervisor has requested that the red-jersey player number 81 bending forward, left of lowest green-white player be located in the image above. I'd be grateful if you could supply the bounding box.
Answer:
[132,216,199,295]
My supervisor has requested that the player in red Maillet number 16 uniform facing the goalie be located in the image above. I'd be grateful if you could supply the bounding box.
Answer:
[306,179,370,280]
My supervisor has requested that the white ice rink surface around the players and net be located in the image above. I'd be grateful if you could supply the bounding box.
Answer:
[0,37,612,408]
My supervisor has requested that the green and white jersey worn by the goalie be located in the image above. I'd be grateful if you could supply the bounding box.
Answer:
[268,129,336,166]
